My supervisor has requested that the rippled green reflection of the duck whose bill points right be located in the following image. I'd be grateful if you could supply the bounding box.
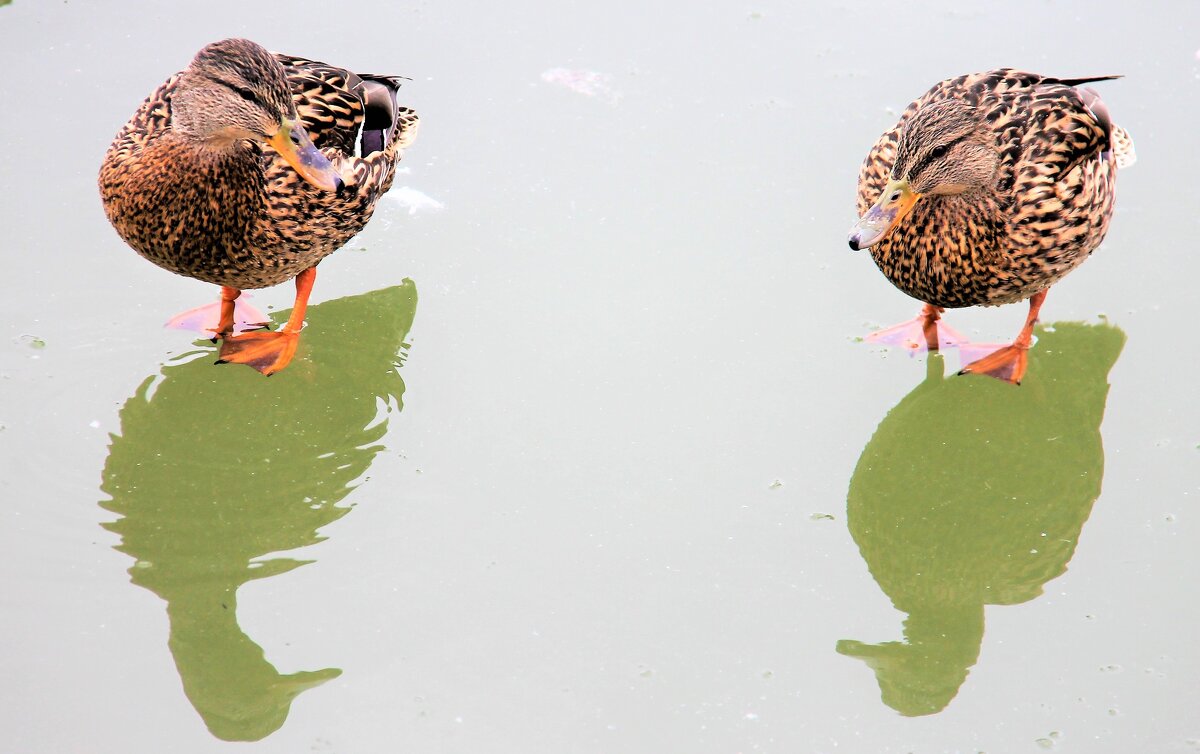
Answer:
[101,280,416,741]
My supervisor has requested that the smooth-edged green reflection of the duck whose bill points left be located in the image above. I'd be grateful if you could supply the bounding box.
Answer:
[838,323,1124,716]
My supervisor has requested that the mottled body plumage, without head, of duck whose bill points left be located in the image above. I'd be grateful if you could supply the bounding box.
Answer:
[858,70,1132,307]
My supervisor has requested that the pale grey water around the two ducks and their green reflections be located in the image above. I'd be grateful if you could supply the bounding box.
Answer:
[0,0,1200,754]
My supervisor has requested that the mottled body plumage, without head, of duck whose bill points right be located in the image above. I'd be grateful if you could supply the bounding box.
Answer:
[100,47,418,289]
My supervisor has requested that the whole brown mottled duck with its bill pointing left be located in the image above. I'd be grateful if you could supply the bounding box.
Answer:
[850,68,1134,384]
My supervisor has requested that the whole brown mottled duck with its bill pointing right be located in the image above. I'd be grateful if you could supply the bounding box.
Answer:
[100,40,418,375]
